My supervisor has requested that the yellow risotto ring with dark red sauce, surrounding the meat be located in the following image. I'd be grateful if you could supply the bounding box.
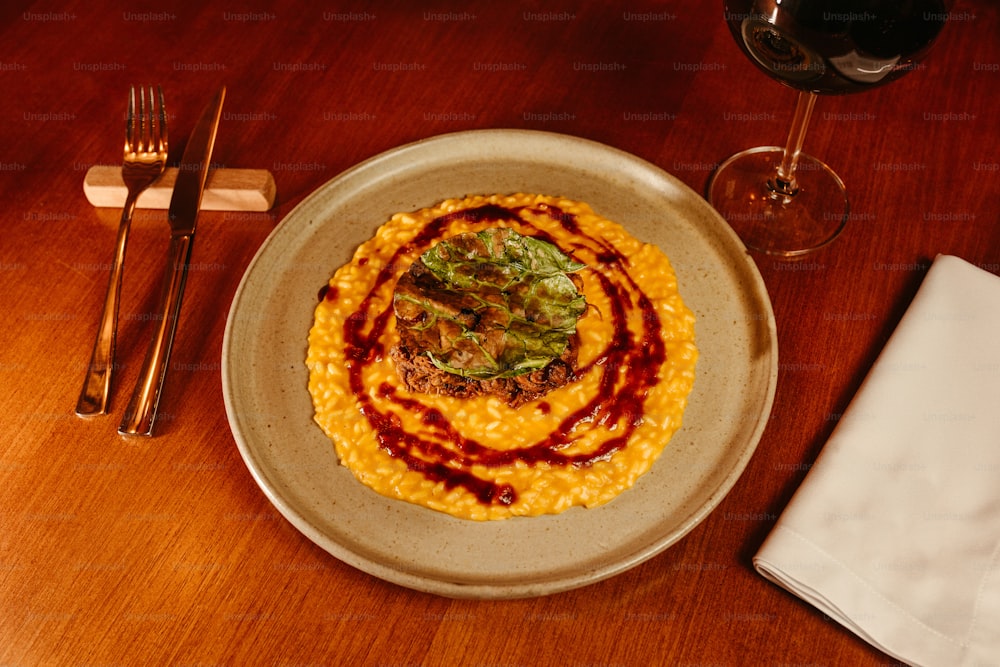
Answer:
[306,194,698,520]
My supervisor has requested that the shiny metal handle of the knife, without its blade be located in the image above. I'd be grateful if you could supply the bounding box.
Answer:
[118,234,194,436]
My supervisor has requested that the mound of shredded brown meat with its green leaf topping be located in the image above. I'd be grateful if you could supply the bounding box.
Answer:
[390,228,586,406]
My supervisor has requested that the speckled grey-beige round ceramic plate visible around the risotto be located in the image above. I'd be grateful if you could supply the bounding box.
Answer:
[222,130,777,598]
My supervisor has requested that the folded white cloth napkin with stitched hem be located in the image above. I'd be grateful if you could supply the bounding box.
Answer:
[753,255,1000,667]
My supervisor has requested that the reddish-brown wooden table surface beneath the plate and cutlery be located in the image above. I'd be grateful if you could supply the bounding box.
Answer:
[0,0,1000,667]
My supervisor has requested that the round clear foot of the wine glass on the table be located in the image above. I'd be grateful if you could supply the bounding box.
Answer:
[706,146,850,257]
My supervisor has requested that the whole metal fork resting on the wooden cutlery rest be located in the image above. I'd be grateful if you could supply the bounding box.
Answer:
[76,86,167,417]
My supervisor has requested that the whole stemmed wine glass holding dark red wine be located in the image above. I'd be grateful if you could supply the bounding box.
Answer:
[707,0,951,257]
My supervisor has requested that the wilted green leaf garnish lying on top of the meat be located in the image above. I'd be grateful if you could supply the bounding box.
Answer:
[395,227,587,380]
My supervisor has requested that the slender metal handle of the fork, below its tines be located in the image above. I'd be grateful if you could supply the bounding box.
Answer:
[76,191,139,417]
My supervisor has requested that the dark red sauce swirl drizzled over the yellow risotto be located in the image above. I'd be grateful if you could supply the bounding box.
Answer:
[340,204,666,505]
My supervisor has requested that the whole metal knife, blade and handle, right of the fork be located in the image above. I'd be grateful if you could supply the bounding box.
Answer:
[118,86,226,436]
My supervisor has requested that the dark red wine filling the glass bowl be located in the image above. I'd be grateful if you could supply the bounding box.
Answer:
[724,0,948,94]
